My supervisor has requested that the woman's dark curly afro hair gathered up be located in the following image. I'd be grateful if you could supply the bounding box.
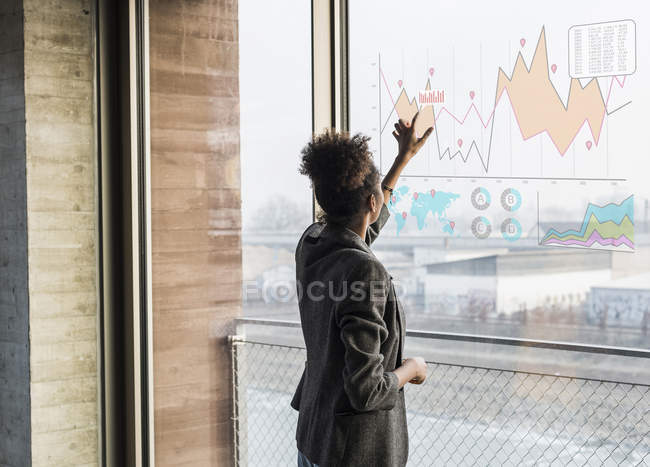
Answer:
[300,130,379,223]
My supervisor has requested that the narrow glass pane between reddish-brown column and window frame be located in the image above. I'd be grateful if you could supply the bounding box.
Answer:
[239,0,312,319]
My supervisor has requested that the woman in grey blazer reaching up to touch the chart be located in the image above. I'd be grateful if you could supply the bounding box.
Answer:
[291,114,431,467]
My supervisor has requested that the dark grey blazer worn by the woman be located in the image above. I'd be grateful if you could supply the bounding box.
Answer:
[291,205,408,467]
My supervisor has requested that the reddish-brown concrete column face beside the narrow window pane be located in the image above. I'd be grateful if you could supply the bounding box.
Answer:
[149,0,241,466]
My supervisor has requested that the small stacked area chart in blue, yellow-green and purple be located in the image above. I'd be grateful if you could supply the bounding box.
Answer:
[538,195,634,252]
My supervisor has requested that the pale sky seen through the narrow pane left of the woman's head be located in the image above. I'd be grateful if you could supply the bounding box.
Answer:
[239,0,311,229]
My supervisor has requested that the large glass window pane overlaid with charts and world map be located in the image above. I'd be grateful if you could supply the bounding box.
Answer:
[350,0,650,354]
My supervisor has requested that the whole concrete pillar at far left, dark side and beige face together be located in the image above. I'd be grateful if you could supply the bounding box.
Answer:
[0,0,98,466]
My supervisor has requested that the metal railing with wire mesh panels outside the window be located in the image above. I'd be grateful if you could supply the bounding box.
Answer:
[230,319,650,466]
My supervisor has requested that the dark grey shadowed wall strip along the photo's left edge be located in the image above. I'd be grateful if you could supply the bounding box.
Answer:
[0,0,30,466]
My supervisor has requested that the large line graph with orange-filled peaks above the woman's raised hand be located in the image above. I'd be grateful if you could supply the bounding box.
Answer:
[378,26,632,181]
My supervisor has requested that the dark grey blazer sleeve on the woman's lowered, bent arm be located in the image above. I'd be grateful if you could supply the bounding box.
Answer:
[336,261,399,412]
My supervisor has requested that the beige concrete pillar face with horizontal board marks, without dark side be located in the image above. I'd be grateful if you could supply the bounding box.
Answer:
[24,0,98,466]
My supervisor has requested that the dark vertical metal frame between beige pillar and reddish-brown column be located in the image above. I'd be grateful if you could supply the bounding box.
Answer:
[93,0,155,466]
